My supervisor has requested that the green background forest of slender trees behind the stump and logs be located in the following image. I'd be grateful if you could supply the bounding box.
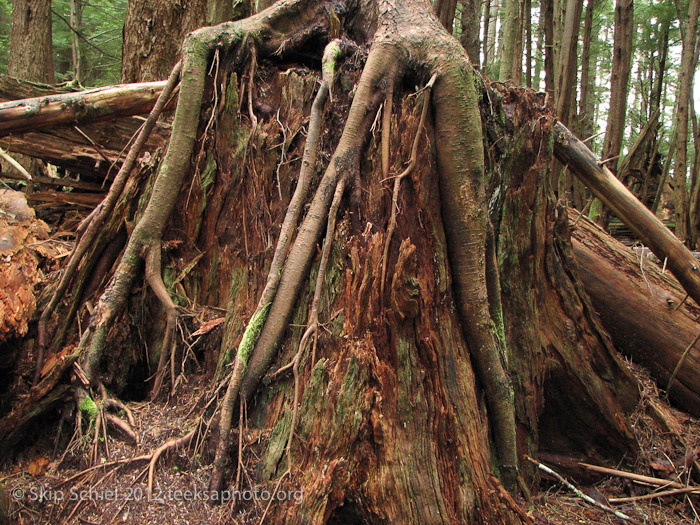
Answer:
[0,0,700,241]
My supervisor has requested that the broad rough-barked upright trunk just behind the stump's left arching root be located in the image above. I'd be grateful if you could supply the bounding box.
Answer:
[122,0,208,82]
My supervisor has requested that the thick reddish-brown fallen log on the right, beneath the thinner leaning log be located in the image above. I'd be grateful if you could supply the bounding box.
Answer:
[570,210,700,416]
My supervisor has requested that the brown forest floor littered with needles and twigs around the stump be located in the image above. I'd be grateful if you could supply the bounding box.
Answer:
[0,198,700,525]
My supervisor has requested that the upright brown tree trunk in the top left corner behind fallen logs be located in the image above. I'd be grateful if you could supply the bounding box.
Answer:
[7,0,55,84]
